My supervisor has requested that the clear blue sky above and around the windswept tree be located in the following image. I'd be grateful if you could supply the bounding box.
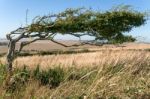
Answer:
[0,0,150,42]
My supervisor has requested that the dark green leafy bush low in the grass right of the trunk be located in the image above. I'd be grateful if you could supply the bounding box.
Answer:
[33,66,64,88]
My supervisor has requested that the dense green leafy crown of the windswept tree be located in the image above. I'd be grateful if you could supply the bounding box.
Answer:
[29,6,147,43]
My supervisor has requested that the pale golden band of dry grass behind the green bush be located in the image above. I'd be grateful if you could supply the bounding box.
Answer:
[1,50,150,68]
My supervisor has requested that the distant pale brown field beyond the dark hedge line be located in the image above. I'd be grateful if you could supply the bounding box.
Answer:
[0,40,150,53]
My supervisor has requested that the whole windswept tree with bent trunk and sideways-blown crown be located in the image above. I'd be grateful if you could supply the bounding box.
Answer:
[7,8,146,72]
